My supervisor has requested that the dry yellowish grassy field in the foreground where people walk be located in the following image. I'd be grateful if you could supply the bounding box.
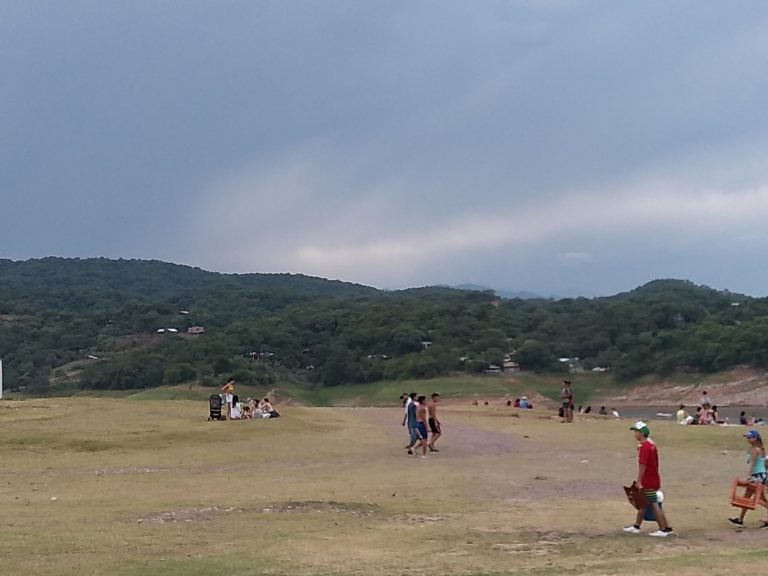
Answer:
[0,396,768,576]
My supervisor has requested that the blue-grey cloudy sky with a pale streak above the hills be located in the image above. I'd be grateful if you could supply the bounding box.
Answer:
[0,0,768,297]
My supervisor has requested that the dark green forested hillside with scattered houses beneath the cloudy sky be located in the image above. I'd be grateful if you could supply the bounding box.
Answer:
[0,258,768,393]
